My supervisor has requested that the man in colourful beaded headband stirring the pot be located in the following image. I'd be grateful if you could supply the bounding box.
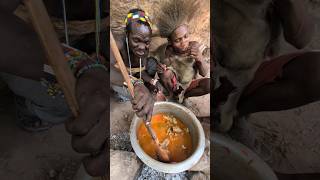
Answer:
[110,9,164,124]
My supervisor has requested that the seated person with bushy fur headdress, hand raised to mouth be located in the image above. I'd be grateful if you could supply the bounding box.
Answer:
[153,0,210,103]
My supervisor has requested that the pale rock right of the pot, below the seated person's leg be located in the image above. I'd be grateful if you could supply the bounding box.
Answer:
[183,94,210,117]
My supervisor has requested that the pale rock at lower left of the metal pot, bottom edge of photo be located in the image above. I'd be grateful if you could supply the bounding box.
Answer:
[110,150,141,180]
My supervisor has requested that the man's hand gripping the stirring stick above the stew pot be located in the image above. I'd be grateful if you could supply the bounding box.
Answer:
[131,84,154,122]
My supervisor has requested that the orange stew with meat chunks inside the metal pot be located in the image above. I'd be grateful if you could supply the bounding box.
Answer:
[137,113,192,162]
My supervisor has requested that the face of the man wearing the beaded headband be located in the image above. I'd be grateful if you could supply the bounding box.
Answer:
[128,22,151,57]
